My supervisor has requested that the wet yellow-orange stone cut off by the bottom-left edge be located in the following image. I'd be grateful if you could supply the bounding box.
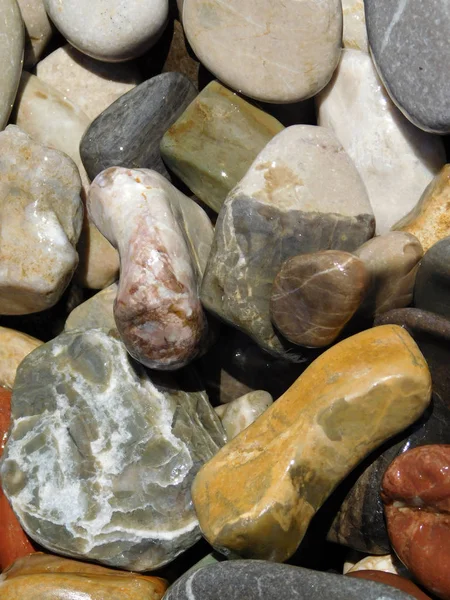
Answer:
[0,553,167,600]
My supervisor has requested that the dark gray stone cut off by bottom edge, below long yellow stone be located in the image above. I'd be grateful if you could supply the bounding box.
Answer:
[164,560,411,600]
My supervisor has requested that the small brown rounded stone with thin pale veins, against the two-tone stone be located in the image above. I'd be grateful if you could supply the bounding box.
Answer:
[270,250,370,348]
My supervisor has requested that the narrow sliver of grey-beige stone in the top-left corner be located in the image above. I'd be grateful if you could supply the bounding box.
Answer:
[0,0,25,130]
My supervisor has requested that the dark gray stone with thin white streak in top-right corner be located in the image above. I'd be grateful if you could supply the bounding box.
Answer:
[364,0,450,133]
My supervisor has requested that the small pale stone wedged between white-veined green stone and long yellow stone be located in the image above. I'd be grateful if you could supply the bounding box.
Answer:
[215,390,273,440]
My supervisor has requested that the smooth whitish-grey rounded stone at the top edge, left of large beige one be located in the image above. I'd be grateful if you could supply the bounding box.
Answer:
[44,0,169,62]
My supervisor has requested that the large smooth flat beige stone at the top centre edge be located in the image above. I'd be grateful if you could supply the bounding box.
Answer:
[183,0,342,103]
